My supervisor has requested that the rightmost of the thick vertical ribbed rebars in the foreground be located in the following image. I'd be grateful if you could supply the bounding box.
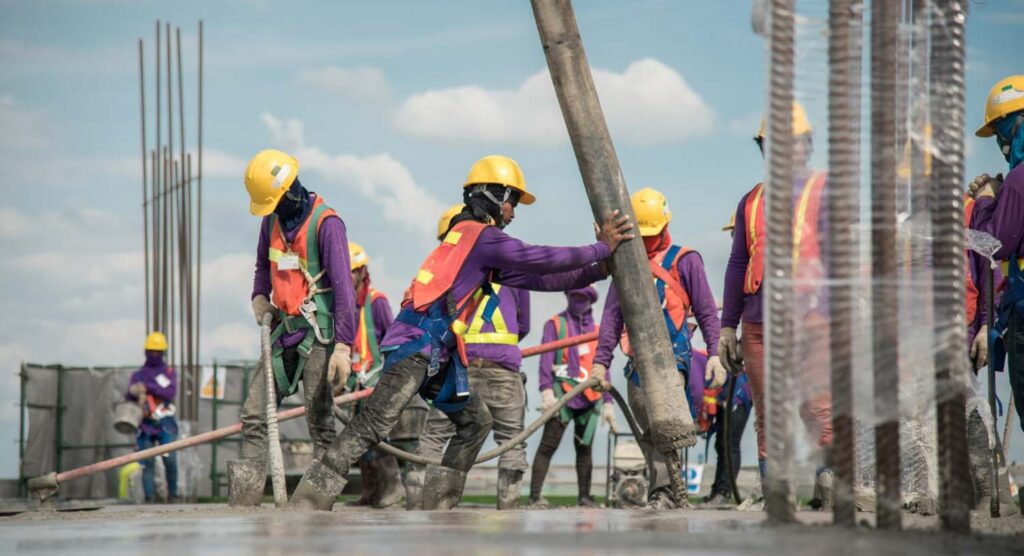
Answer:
[930,0,966,532]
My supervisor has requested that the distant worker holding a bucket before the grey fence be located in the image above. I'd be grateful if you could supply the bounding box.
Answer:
[125,332,178,503]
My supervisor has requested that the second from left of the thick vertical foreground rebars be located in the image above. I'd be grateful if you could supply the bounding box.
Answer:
[825,0,860,526]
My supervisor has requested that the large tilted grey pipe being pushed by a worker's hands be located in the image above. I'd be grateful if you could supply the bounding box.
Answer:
[530,0,696,453]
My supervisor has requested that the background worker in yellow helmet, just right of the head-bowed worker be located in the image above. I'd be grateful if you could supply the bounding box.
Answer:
[346,242,401,508]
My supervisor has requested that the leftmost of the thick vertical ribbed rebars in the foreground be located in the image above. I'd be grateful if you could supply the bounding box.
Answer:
[762,0,796,523]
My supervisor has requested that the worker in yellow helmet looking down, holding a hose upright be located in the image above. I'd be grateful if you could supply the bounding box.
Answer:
[227,149,356,506]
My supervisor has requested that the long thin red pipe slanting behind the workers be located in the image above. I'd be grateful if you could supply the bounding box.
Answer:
[44,332,597,491]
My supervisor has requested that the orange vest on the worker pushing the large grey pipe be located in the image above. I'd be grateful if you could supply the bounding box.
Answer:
[401,220,488,311]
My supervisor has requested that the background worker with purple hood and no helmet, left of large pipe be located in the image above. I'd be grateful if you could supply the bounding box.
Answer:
[529,286,615,508]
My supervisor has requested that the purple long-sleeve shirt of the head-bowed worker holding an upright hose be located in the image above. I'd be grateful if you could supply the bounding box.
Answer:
[251,193,356,347]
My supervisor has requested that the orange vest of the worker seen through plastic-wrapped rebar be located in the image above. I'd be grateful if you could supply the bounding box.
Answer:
[743,172,827,295]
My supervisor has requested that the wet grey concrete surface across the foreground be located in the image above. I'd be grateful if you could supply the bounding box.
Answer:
[0,505,1024,556]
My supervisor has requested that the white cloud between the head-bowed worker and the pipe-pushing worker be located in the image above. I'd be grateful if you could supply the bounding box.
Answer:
[262,114,445,238]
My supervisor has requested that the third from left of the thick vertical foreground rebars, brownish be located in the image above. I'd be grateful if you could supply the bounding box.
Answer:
[871,2,902,529]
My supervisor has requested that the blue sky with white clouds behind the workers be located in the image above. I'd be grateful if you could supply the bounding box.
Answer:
[0,0,1024,476]
